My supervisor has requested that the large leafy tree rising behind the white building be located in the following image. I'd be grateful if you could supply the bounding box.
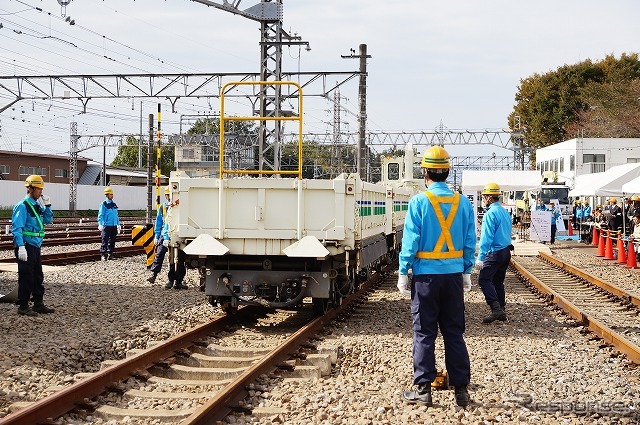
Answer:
[508,53,640,158]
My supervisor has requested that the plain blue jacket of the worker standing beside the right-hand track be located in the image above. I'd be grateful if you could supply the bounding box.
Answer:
[478,202,511,261]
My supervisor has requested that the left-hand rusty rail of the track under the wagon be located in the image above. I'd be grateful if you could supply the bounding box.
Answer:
[0,307,250,425]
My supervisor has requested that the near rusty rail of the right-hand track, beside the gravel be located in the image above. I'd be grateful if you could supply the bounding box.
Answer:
[511,258,640,364]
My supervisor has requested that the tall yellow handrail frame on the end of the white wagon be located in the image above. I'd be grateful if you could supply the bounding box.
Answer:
[219,81,302,179]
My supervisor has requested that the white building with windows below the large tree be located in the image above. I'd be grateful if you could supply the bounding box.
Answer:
[536,138,640,187]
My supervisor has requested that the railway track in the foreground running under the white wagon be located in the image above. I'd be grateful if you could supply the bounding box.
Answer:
[0,264,390,425]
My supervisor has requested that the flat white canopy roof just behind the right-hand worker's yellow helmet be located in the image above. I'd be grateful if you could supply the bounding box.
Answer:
[461,170,542,192]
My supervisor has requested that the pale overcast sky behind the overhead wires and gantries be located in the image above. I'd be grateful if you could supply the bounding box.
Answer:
[0,0,640,162]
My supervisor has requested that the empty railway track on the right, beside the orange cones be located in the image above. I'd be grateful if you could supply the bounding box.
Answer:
[511,253,640,364]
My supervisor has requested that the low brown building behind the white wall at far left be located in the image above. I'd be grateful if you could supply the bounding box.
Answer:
[0,151,89,183]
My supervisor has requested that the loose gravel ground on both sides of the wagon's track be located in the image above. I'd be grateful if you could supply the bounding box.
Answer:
[0,243,640,424]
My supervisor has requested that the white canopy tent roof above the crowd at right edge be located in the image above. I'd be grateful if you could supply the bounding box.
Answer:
[569,163,640,196]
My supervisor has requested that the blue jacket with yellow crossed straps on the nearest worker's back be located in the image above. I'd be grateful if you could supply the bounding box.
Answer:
[398,182,476,275]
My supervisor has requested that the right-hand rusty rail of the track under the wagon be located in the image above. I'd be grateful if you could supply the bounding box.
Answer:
[182,266,388,425]
